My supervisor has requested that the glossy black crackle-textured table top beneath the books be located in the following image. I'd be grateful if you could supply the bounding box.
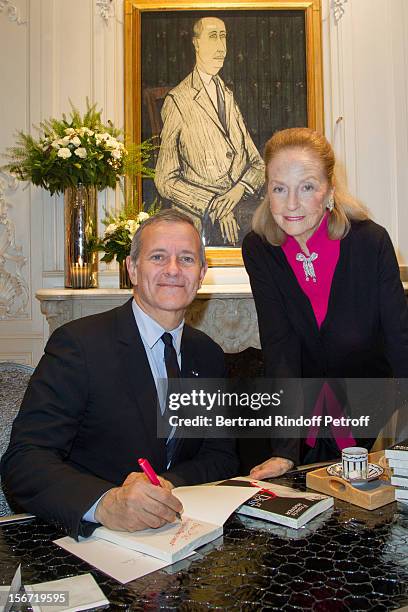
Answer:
[0,473,408,612]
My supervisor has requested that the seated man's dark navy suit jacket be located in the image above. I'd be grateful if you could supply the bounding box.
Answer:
[2,300,237,537]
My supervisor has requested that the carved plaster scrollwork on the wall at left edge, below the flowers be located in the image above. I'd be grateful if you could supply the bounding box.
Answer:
[0,170,29,320]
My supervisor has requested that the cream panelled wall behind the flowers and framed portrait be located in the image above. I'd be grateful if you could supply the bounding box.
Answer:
[0,0,408,363]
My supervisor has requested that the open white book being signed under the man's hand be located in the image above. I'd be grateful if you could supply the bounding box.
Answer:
[93,485,254,563]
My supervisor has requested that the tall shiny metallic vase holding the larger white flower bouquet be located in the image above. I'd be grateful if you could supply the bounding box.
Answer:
[64,184,98,289]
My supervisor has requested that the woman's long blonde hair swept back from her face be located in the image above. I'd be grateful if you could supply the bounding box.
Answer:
[252,128,369,246]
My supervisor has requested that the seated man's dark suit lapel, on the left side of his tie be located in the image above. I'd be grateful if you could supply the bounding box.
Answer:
[116,298,166,469]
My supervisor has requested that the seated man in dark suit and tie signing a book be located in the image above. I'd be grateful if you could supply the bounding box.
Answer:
[2,210,237,537]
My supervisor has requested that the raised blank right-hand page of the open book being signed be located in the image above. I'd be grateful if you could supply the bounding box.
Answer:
[172,485,256,526]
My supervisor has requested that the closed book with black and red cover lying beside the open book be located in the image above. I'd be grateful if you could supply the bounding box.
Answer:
[220,478,334,529]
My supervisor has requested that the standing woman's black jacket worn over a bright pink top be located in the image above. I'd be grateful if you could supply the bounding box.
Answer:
[242,221,408,462]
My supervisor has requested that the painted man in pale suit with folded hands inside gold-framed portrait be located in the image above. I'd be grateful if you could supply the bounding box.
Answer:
[155,17,264,246]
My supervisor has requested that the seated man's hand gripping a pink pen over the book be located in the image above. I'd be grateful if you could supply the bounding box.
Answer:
[95,472,183,531]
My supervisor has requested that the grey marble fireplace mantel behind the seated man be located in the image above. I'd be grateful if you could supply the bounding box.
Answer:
[36,284,260,353]
